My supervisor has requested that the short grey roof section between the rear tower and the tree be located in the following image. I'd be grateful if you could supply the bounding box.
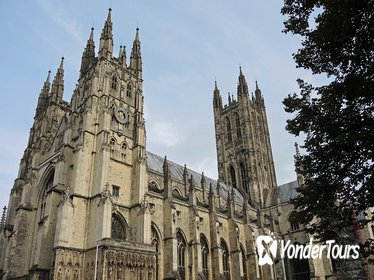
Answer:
[265,181,299,207]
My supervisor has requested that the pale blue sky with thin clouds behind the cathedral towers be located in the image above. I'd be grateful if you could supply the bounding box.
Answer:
[0,0,315,210]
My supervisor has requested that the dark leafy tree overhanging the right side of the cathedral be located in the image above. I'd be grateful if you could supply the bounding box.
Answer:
[281,0,374,256]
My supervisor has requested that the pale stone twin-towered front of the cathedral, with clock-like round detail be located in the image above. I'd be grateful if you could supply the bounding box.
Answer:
[0,9,154,279]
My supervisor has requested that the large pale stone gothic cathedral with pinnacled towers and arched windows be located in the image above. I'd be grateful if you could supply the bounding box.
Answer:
[0,9,372,280]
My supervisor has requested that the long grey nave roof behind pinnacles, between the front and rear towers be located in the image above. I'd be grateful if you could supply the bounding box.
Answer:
[147,151,243,204]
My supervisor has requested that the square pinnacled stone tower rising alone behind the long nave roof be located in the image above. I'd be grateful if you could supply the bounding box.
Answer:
[213,68,277,205]
